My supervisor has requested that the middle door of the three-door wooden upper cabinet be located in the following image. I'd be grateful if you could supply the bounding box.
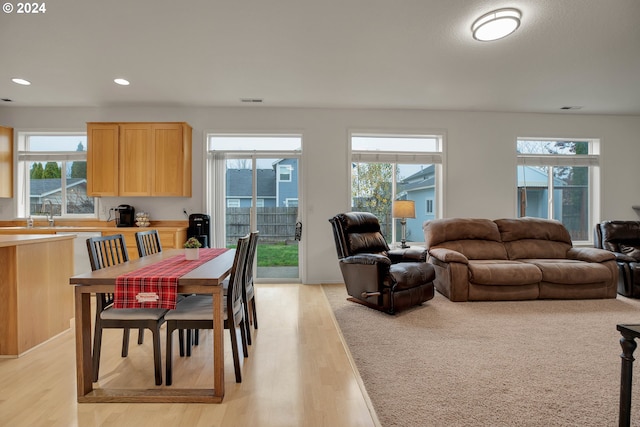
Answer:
[120,123,153,197]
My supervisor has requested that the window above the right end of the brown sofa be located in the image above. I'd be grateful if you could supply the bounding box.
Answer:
[517,138,600,242]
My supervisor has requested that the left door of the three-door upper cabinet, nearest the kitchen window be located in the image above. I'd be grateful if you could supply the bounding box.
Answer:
[87,123,119,197]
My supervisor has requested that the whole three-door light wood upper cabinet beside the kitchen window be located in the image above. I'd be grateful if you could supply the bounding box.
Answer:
[87,123,192,197]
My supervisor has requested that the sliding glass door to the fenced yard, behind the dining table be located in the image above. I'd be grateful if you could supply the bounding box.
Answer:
[209,135,301,281]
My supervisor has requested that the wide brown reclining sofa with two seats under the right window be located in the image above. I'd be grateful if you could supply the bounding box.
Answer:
[423,218,618,301]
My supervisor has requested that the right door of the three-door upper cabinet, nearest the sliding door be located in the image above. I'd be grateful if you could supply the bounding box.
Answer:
[151,123,191,197]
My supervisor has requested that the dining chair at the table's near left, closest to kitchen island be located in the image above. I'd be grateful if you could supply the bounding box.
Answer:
[87,234,167,385]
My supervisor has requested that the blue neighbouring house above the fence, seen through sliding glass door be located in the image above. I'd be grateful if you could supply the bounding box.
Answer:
[226,159,298,208]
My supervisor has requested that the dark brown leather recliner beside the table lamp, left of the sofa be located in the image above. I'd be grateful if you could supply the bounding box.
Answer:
[329,212,435,314]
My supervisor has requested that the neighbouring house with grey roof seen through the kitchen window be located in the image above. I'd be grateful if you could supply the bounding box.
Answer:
[29,178,93,215]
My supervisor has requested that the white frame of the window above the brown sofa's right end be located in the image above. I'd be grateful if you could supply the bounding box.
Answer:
[516,137,600,246]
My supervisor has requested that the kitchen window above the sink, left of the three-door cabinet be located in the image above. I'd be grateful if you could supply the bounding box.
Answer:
[17,132,97,218]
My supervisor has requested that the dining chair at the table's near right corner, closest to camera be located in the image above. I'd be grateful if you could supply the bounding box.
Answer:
[164,235,249,385]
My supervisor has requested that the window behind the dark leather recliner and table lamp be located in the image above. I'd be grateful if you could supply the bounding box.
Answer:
[351,134,443,247]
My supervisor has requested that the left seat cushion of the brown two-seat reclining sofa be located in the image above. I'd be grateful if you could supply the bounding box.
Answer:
[469,260,542,285]
